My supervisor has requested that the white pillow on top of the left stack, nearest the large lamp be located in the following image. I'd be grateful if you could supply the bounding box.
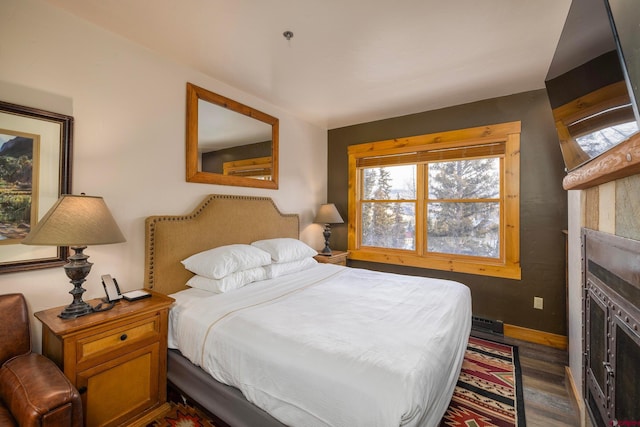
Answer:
[182,244,271,279]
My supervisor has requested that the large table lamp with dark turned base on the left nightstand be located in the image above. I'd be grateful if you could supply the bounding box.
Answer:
[22,194,126,319]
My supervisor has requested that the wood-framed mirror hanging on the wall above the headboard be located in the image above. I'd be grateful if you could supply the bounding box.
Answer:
[186,83,279,189]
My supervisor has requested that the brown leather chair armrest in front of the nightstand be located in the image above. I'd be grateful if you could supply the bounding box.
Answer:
[0,353,82,427]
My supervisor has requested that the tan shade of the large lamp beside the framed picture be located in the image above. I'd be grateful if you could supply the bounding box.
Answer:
[22,195,126,246]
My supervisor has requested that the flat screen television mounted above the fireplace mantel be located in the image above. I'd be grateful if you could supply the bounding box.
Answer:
[545,0,640,171]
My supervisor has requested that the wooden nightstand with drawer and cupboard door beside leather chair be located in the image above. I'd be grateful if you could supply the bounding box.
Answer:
[35,292,174,427]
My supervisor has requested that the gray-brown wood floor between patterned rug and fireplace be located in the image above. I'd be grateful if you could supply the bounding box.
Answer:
[473,331,580,427]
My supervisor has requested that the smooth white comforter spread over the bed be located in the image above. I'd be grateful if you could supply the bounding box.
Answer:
[169,264,471,427]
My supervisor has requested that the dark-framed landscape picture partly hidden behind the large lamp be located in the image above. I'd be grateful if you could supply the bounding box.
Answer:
[0,101,73,273]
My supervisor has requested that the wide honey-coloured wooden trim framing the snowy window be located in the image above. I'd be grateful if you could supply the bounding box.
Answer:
[348,121,521,280]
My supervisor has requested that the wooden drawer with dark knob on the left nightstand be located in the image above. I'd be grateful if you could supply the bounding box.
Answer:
[76,315,160,363]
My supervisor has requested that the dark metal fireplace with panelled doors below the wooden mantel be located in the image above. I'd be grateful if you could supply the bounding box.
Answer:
[582,228,640,426]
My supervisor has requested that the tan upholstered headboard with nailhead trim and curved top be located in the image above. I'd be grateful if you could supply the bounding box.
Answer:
[144,194,300,294]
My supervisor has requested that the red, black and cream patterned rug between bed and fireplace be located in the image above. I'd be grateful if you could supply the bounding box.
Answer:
[440,337,526,427]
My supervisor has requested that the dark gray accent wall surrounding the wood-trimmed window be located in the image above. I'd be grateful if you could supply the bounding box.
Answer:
[328,89,567,335]
